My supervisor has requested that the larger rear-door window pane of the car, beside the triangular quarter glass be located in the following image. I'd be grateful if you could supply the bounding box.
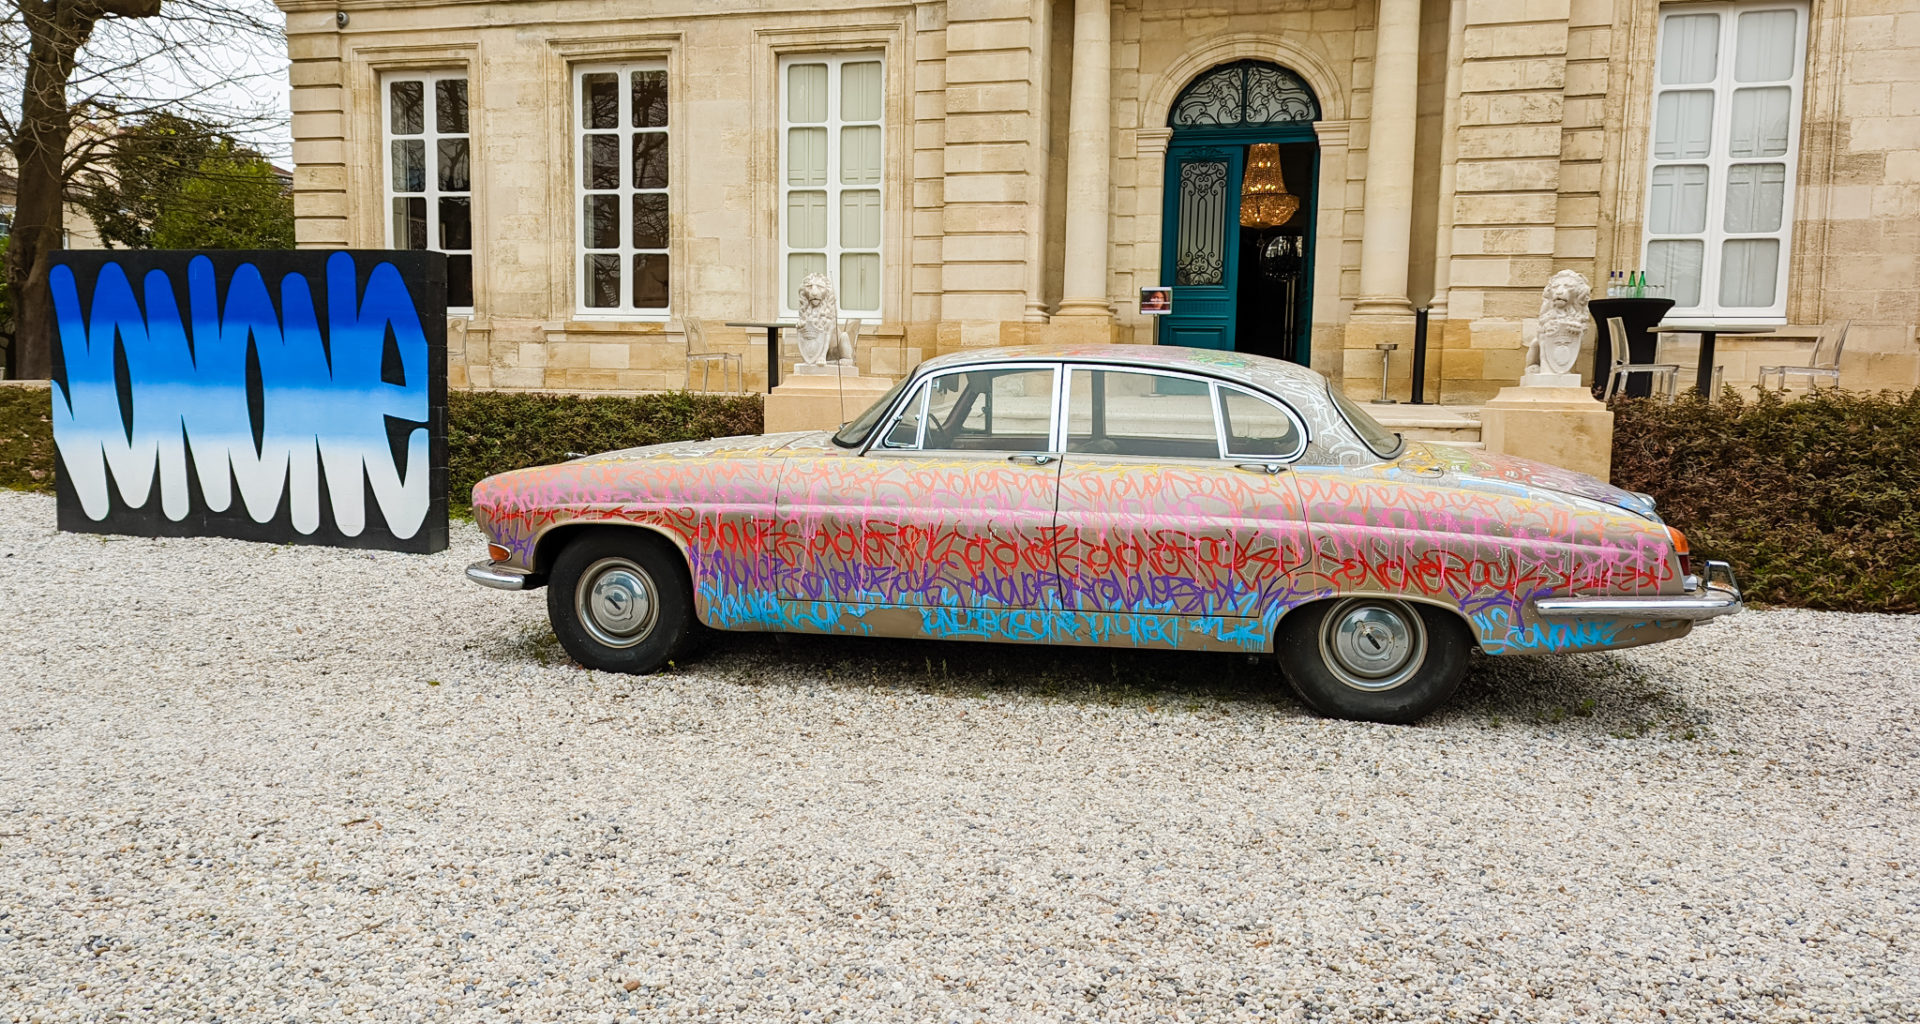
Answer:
[1068,367,1219,459]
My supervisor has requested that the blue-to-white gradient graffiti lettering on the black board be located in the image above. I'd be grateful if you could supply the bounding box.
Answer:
[50,252,432,538]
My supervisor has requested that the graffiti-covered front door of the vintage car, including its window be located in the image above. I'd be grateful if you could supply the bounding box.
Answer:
[778,363,1060,611]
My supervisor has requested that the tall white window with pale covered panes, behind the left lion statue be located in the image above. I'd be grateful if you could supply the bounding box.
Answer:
[780,54,885,317]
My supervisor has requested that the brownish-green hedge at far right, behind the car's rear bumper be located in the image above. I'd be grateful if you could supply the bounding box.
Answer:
[1613,388,1920,611]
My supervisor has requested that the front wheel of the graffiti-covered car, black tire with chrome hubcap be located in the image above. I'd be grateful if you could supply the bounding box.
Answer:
[547,528,699,676]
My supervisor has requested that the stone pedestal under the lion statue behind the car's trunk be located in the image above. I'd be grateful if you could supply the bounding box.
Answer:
[1480,384,1613,480]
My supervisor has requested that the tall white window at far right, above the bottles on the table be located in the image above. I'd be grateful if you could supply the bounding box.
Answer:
[1645,2,1807,321]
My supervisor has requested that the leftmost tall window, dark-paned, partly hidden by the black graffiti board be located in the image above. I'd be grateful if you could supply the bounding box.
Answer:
[382,73,474,313]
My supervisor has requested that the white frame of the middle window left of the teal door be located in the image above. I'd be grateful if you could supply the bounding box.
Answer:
[566,58,682,323]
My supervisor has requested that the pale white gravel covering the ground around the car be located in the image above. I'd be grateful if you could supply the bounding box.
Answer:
[0,492,1920,1022]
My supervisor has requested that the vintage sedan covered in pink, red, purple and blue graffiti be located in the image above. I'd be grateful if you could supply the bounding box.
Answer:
[467,346,1741,722]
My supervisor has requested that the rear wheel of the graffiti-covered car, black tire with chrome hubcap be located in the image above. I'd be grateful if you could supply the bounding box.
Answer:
[1273,597,1473,724]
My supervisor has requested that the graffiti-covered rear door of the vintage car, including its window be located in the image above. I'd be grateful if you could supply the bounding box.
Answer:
[1058,367,1311,637]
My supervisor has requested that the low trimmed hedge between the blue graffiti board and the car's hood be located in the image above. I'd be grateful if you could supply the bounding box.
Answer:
[447,392,760,509]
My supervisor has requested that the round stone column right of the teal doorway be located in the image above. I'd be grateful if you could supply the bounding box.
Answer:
[1354,0,1421,319]
